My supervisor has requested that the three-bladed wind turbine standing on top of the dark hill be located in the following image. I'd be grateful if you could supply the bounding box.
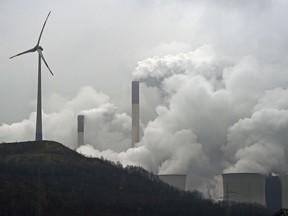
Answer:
[10,11,54,141]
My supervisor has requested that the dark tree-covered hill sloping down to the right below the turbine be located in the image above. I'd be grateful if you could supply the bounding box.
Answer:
[0,141,269,216]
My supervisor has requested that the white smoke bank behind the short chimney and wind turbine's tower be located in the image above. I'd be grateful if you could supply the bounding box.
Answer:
[0,86,131,151]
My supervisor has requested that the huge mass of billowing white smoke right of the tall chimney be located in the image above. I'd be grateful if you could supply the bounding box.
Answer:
[79,45,288,197]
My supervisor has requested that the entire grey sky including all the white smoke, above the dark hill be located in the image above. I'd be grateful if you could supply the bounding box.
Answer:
[0,0,288,198]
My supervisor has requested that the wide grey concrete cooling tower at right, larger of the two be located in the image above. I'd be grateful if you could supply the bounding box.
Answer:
[222,173,266,206]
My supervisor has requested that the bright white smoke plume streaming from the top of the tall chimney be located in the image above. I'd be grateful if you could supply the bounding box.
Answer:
[132,45,229,87]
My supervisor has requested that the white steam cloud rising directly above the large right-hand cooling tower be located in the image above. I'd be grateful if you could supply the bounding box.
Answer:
[223,88,288,174]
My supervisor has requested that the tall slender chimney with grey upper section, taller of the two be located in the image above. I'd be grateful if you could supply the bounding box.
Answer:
[132,81,139,148]
